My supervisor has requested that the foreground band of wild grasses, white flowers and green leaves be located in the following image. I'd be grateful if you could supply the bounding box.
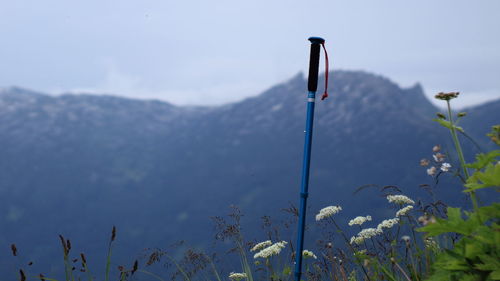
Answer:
[7,93,500,281]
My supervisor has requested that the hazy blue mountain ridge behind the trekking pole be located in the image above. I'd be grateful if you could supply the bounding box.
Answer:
[0,71,500,273]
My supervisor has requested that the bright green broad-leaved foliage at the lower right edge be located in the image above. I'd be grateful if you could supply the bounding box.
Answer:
[417,150,500,281]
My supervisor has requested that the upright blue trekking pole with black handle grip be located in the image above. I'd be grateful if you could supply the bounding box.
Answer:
[295,37,325,281]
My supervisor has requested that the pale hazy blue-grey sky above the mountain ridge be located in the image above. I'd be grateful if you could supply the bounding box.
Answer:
[0,0,500,107]
